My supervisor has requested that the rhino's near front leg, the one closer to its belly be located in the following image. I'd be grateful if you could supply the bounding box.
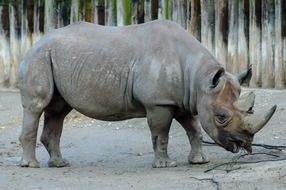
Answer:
[147,107,177,168]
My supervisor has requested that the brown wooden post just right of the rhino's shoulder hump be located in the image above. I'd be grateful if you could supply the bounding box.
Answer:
[187,0,201,41]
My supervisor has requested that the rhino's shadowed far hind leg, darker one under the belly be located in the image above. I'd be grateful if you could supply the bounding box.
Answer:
[41,91,72,167]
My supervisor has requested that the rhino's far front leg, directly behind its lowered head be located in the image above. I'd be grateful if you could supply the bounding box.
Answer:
[176,116,209,164]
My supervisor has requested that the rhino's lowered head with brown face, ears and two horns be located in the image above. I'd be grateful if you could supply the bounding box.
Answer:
[197,68,276,153]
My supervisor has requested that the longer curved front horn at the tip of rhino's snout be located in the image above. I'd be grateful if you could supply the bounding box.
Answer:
[245,105,277,134]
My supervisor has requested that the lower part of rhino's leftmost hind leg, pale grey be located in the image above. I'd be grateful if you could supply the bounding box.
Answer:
[19,108,41,168]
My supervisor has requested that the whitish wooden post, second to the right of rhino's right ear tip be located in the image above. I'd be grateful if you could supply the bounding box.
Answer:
[261,0,274,88]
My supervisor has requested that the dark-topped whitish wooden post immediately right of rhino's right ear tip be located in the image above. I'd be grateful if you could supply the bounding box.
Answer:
[249,0,262,87]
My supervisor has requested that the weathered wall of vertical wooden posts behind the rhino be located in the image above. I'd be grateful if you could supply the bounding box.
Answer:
[0,0,286,88]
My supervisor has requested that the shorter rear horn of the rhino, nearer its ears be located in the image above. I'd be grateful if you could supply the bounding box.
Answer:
[234,92,255,113]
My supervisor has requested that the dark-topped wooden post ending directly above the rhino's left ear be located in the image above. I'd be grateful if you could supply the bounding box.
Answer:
[215,0,228,67]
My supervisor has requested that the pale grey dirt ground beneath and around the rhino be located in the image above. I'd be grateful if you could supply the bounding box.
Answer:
[0,89,286,190]
